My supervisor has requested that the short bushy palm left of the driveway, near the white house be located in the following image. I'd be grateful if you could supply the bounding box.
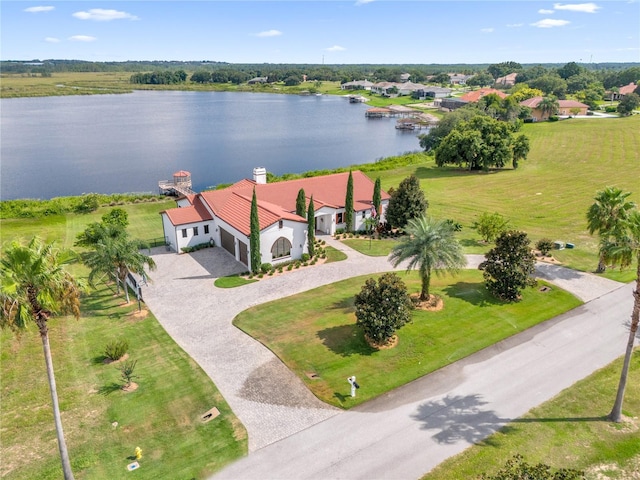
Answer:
[83,234,156,303]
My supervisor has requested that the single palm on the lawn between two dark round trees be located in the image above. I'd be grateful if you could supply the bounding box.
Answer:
[389,216,467,300]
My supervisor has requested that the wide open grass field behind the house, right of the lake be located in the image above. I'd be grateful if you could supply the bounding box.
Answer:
[371,115,640,281]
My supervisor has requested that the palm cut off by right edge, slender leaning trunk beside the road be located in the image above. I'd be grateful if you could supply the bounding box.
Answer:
[604,210,640,422]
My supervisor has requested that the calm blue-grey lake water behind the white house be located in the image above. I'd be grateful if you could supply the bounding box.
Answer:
[0,91,420,200]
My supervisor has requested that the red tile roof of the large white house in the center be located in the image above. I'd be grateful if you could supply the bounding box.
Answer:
[163,170,390,235]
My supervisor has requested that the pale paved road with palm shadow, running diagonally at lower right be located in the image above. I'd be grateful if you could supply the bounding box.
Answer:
[213,285,632,480]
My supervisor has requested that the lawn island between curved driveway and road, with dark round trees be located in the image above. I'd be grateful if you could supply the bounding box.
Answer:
[234,270,580,408]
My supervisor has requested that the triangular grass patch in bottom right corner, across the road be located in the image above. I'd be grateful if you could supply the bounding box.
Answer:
[423,352,640,480]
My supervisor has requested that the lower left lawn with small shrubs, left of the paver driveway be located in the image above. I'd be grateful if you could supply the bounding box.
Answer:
[0,286,247,480]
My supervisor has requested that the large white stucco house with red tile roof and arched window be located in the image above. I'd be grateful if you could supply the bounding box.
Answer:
[160,167,390,270]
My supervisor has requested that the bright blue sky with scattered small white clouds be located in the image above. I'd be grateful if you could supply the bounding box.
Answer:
[0,0,640,64]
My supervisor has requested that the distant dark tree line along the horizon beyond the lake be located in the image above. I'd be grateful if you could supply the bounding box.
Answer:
[0,59,640,89]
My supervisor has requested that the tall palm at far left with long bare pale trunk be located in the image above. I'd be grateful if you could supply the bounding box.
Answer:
[0,237,80,480]
